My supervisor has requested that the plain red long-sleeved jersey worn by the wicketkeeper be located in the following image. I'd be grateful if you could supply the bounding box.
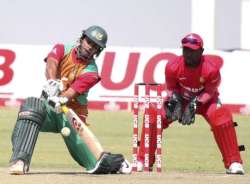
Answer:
[165,55,223,103]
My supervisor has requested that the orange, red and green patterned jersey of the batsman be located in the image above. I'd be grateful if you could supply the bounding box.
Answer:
[48,44,99,121]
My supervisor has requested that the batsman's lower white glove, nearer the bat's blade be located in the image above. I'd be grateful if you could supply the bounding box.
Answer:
[47,96,68,114]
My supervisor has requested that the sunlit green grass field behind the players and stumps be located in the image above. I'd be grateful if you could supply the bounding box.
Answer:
[0,108,250,183]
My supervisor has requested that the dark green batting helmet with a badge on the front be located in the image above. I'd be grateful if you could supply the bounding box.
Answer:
[81,26,108,48]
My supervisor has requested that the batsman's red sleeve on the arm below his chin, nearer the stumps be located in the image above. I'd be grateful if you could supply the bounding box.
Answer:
[70,72,101,94]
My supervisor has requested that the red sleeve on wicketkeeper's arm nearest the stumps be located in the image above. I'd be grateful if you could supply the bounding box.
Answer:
[165,61,180,97]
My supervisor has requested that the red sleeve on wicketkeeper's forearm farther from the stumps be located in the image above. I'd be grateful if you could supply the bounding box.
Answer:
[197,71,221,104]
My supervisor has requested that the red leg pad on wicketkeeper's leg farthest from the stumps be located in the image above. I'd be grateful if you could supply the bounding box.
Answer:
[209,107,242,168]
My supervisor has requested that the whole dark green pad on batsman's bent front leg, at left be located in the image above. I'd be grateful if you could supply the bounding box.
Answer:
[10,97,46,166]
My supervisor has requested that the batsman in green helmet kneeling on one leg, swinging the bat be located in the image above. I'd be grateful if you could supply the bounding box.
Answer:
[9,26,131,175]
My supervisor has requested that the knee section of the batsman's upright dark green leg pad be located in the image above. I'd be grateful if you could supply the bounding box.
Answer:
[17,97,46,127]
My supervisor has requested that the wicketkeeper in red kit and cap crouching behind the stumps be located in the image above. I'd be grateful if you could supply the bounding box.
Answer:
[137,33,244,174]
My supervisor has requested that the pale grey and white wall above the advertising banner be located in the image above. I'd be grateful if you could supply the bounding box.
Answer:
[0,0,250,49]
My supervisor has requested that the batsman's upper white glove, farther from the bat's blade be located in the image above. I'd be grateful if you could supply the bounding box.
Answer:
[42,79,63,98]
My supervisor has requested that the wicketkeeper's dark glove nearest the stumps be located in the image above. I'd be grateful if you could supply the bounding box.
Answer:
[164,93,182,121]
